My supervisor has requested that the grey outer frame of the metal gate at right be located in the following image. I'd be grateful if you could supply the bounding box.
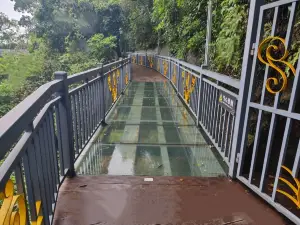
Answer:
[233,0,300,224]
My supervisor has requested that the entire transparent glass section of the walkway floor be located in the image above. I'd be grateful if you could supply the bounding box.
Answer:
[76,82,227,177]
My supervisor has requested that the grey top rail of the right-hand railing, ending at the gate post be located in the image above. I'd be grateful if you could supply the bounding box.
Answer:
[135,53,240,89]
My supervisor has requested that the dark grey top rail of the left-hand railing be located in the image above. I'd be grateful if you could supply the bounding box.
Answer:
[0,58,128,159]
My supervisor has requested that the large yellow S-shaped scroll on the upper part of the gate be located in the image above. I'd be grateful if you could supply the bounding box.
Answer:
[258,37,296,94]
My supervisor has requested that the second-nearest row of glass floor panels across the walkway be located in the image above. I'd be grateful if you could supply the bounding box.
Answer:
[97,121,206,145]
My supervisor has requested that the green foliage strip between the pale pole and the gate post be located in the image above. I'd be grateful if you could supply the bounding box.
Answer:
[211,0,247,78]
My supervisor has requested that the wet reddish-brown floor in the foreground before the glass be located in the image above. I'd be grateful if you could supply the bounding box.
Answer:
[54,176,287,225]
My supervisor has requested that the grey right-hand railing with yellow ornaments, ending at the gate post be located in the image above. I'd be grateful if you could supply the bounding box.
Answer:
[132,54,240,171]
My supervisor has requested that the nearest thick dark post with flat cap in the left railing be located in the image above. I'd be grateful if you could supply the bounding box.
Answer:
[54,71,75,177]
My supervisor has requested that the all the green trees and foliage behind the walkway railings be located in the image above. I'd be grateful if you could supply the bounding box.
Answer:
[0,0,300,118]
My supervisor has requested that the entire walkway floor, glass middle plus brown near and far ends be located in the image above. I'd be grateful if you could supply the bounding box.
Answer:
[54,67,286,225]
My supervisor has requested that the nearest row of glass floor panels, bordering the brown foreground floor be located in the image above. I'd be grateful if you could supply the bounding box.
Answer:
[77,143,226,177]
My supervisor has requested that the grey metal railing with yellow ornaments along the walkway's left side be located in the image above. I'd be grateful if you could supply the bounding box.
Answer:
[0,58,131,225]
